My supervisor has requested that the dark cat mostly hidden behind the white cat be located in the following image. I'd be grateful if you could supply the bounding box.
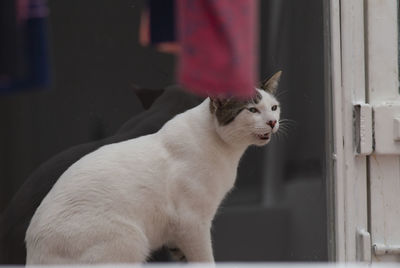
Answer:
[0,85,200,264]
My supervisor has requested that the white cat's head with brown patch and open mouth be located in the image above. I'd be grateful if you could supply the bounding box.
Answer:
[210,71,282,146]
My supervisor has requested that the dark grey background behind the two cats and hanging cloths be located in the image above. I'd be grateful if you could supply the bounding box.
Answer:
[0,0,328,261]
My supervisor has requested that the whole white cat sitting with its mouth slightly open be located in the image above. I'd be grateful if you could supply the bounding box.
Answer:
[25,72,281,264]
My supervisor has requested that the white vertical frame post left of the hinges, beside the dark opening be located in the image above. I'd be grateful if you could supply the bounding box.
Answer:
[331,0,368,262]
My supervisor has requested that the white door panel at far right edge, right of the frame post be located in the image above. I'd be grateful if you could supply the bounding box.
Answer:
[366,0,400,267]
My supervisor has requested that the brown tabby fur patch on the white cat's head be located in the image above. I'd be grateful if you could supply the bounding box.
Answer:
[210,90,262,126]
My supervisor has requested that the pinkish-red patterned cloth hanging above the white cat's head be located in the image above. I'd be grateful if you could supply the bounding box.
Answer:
[176,0,258,97]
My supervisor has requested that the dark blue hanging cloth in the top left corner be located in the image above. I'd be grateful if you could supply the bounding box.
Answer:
[0,0,50,93]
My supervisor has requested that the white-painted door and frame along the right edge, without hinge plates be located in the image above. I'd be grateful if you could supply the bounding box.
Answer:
[327,0,400,262]
